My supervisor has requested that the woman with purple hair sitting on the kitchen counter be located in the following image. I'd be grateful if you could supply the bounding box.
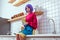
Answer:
[18,4,37,40]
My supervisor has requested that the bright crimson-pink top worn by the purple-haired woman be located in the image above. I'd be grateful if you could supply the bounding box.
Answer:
[26,12,37,29]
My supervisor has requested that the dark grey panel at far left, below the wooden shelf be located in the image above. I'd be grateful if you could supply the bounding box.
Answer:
[0,18,10,35]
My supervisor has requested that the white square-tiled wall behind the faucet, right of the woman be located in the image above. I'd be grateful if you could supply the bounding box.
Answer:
[36,0,60,33]
